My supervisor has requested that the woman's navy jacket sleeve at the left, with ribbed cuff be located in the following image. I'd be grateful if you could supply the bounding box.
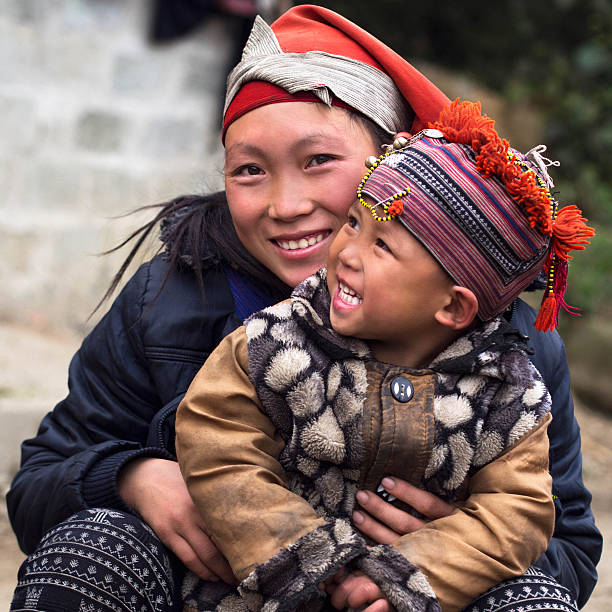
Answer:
[7,264,173,553]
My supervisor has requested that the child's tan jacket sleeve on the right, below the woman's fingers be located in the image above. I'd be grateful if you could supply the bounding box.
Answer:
[378,415,554,612]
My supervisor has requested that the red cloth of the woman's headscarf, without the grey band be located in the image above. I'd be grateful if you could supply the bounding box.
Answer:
[223,4,449,134]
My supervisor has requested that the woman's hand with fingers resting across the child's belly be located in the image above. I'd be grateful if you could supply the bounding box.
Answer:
[353,477,454,544]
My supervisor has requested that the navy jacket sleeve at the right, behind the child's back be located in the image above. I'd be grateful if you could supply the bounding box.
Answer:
[511,300,602,607]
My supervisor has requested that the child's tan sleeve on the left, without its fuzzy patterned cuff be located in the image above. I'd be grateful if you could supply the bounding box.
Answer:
[176,328,325,579]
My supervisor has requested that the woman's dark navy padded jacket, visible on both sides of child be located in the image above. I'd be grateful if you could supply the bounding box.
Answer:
[7,256,602,604]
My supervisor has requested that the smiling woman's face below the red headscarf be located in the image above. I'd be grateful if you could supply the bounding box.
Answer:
[225,102,377,287]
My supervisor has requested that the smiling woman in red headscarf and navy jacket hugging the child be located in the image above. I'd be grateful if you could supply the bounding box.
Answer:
[7,6,601,610]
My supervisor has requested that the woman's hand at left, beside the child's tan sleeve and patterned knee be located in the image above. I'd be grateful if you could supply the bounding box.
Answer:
[117,457,237,584]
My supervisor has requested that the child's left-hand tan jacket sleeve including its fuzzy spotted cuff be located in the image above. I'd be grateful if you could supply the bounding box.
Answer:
[176,328,365,610]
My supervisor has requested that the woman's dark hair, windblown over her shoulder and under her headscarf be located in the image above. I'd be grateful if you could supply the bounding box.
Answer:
[92,111,392,315]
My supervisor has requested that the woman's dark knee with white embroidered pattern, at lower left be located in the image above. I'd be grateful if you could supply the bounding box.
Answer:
[13,509,174,612]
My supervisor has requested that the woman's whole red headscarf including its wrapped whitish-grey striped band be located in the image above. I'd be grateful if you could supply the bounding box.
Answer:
[223,5,448,138]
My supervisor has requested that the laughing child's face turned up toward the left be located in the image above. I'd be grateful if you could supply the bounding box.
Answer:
[327,202,454,365]
